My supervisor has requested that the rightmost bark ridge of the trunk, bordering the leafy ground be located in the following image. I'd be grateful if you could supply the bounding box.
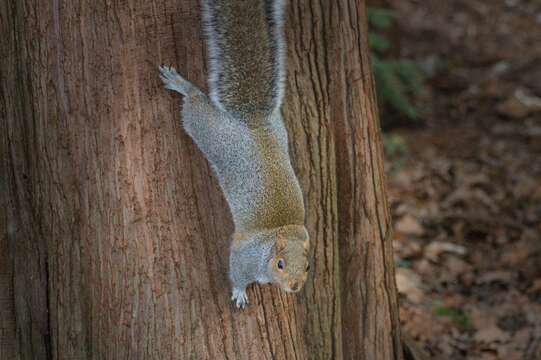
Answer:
[336,1,402,359]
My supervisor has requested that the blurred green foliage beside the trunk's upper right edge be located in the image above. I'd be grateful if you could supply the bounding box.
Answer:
[368,8,424,120]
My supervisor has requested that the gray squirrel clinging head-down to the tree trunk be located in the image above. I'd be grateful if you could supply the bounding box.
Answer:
[160,0,309,308]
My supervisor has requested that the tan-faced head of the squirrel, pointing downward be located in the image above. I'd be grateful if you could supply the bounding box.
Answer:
[267,225,310,292]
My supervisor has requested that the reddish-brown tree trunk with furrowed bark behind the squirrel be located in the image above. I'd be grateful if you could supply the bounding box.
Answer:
[0,0,402,360]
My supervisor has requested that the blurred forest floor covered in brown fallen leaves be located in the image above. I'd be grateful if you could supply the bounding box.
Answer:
[383,0,541,360]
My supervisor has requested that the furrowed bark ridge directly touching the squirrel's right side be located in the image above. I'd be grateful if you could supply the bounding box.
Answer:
[284,1,342,359]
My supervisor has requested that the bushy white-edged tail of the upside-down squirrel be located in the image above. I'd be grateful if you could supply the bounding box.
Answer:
[203,0,285,119]
